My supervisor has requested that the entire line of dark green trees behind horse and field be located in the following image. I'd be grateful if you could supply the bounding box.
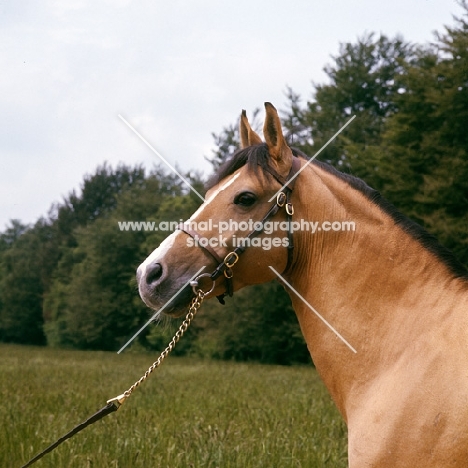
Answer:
[0,6,468,364]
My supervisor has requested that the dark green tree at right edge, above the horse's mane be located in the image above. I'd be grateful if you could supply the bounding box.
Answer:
[382,10,468,264]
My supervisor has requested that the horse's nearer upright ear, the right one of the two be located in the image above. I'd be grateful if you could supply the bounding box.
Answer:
[263,102,293,175]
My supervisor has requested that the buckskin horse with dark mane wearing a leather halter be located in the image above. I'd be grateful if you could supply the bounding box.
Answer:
[137,103,468,468]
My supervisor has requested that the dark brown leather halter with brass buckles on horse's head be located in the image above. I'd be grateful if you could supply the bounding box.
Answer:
[177,156,301,304]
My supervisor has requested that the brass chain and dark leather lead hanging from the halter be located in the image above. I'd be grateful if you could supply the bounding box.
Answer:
[21,289,206,468]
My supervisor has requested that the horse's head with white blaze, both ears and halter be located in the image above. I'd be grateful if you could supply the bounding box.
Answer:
[137,103,300,315]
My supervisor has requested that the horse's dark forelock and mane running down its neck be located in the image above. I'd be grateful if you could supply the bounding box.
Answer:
[206,143,468,280]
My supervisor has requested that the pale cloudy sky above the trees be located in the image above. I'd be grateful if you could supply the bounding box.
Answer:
[0,0,462,231]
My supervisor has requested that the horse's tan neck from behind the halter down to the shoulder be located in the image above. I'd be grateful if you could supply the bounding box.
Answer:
[288,166,468,415]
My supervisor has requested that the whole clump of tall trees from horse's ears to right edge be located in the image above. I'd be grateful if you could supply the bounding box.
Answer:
[278,12,468,265]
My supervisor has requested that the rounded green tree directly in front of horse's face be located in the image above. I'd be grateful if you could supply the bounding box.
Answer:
[45,166,203,350]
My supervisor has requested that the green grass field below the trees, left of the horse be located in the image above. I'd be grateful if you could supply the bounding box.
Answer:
[0,345,347,468]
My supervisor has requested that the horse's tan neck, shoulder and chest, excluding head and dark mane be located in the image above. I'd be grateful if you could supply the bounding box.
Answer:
[288,166,468,467]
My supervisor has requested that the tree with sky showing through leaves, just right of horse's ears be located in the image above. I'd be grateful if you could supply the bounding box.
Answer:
[283,34,412,170]
